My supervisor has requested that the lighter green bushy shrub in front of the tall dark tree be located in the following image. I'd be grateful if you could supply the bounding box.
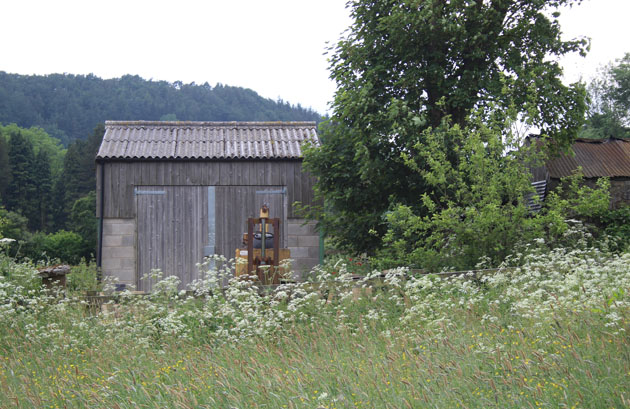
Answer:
[377,119,610,271]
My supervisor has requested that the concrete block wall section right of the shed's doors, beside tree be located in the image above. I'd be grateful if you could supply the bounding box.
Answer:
[288,219,319,279]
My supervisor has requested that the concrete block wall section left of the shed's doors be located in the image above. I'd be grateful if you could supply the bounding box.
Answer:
[101,219,136,286]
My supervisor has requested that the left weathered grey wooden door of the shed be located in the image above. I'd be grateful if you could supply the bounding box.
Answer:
[135,186,209,291]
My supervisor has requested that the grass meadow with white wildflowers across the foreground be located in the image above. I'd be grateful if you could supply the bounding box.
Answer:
[0,249,630,408]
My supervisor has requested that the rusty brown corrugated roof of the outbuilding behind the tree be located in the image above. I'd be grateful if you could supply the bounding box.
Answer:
[546,138,630,178]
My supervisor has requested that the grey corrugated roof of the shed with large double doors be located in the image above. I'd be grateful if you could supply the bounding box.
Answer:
[96,121,319,159]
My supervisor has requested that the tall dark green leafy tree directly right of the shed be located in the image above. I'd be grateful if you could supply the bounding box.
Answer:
[305,0,587,251]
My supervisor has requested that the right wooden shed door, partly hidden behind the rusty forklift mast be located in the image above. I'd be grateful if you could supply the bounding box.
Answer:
[216,186,288,259]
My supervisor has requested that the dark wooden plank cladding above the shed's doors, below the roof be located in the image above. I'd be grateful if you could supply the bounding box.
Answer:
[97,161,314,219]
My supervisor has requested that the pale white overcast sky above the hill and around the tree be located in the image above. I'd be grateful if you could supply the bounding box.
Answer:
[0,0,630,113]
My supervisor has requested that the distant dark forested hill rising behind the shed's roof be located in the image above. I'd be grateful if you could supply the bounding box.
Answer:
[0,71,321,146]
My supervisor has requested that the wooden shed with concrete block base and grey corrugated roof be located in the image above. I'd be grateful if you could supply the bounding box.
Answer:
[96,121,319,291]
